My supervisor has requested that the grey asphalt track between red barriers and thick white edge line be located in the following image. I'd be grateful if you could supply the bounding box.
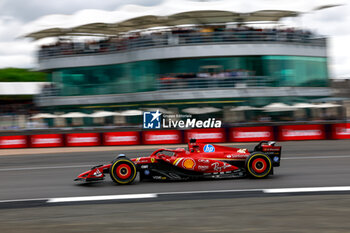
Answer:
[0,140,350,201]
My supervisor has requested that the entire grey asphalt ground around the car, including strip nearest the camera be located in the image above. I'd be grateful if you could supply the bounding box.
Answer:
[0,140,350,232]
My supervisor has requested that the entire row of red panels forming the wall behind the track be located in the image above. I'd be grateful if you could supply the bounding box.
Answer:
[0,123,350,149]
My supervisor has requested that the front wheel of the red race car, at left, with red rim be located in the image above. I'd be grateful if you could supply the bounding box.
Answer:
[109,157,137,184]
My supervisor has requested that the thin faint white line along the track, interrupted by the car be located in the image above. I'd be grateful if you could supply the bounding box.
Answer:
[0,155,350,172]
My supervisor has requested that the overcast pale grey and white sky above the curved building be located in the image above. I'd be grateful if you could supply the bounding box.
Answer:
[0,0,350,78]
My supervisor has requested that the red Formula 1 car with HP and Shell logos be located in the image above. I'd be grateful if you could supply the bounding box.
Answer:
[75,139,281,184]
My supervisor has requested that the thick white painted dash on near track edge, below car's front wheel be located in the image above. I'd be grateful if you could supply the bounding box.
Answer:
[47,193,158,203]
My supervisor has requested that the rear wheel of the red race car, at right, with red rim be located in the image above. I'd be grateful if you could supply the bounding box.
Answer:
[246,152,272,178]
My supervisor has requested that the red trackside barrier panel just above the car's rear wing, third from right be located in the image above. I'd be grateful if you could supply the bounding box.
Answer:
[230,126,274,142]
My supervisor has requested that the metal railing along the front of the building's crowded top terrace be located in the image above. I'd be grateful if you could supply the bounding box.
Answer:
[38,31,326,60]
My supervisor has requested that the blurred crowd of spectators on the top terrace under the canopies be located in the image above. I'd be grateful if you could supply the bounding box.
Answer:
[39,26,312,59]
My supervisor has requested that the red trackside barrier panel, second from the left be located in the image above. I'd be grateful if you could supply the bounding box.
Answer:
[30,134,64,147]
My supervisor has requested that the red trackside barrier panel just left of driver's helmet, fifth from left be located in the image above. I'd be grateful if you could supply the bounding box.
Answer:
[142,130,182,144]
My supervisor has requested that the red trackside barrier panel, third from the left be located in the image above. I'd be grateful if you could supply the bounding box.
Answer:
[66,133,100,146]
